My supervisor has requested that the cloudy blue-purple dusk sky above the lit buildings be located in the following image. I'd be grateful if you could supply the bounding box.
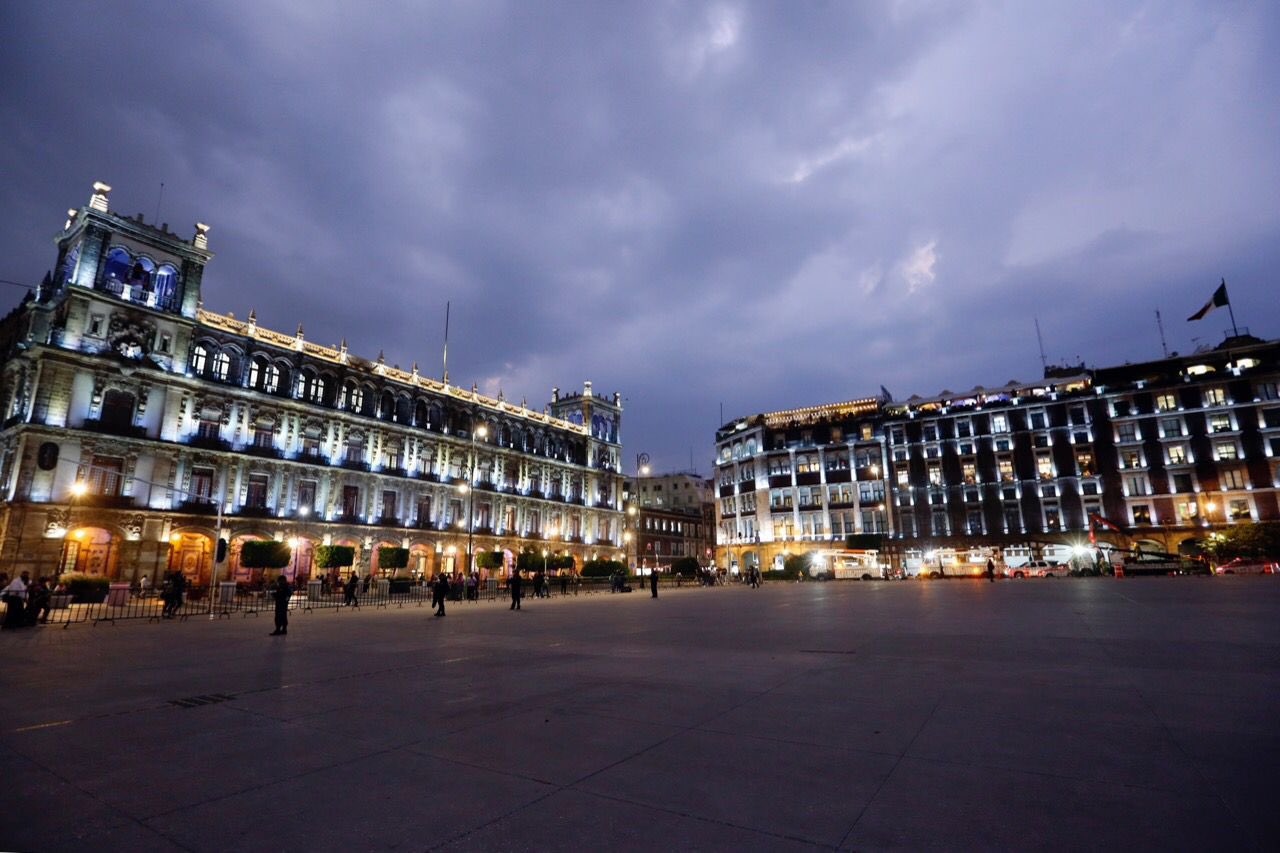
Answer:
[0,0,1280,473]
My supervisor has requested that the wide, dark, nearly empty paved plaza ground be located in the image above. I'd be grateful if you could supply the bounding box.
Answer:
[0,578,1280,850]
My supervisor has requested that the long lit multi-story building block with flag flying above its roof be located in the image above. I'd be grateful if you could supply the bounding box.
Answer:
[716,336,1280,567]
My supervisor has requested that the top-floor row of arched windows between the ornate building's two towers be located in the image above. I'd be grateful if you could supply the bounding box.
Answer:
[191,341,586,465]
